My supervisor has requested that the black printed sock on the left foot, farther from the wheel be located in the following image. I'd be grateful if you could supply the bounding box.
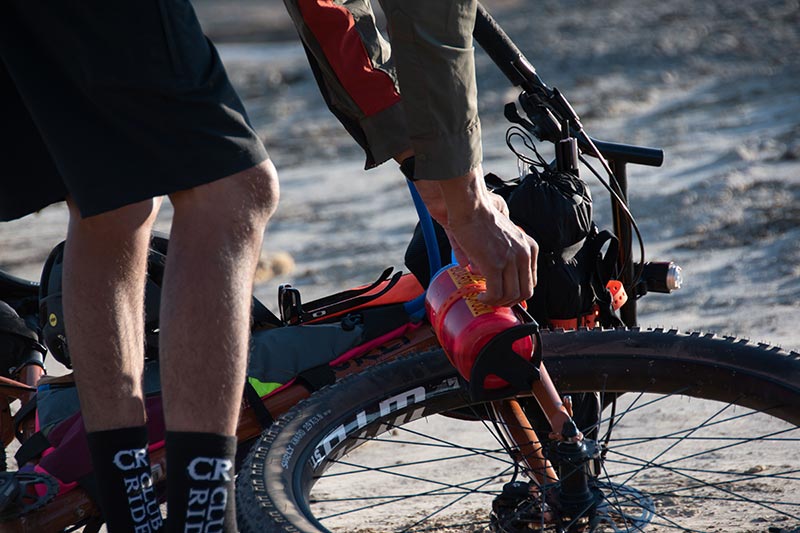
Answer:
[86,426,163,533]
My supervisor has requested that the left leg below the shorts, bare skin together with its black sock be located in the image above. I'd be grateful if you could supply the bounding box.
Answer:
[63,200,162,532]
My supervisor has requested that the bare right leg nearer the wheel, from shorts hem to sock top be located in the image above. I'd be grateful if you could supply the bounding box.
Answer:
[159,160,278,436]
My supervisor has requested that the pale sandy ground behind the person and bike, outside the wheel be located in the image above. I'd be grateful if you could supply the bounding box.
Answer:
[0,0,800,531]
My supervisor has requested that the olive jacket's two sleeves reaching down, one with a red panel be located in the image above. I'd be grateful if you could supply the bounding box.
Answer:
[284,0,482,179]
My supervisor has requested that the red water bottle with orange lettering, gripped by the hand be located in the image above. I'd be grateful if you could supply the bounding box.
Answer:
[425,266,534,389]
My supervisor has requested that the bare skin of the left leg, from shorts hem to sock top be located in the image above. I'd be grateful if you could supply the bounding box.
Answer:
[63,200,160,432]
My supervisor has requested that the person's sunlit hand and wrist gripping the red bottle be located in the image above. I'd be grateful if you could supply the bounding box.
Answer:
[417,167,539,306]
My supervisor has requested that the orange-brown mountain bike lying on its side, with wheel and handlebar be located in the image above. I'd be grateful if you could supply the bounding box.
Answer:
[0,4,800,533]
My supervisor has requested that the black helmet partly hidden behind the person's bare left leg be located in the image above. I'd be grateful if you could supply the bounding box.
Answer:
[39,234,167,368]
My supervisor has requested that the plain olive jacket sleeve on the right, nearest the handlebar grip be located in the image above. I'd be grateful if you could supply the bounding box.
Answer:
[383,0,482,180]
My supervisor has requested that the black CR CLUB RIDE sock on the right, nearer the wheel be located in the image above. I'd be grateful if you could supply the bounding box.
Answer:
[166,431,236,533]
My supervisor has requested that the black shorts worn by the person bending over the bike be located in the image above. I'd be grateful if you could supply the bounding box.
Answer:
[0,0,267,220]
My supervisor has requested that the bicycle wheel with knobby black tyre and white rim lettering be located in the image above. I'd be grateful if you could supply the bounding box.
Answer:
[237,329,800,533]
